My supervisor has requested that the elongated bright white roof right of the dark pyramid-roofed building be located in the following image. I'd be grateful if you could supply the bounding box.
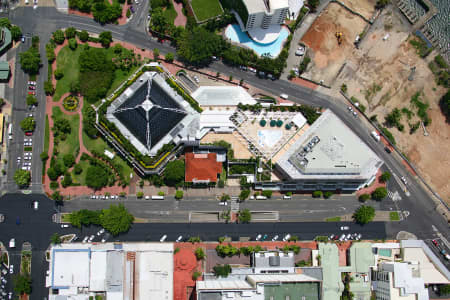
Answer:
[192,86,256,106]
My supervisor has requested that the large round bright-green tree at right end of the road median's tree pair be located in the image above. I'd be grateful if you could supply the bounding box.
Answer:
[99,204,134,235]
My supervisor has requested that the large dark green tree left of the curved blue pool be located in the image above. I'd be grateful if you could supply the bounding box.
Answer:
[177,26,226,65]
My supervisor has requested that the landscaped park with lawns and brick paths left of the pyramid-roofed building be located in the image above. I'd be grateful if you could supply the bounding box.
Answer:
[41,28,143,198]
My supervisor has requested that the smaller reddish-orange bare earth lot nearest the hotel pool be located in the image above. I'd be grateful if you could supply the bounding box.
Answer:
[301,1,366,85]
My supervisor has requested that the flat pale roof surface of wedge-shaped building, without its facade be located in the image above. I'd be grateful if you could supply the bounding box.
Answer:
[277,110,383,179]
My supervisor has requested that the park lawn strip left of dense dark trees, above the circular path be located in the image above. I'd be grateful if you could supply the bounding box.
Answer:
[53,45,81,101]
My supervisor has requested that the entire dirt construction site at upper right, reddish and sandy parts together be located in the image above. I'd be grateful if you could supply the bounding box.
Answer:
[302,0,450,203]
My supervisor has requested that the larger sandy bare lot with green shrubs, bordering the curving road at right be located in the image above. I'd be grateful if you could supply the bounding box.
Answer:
[333,7,450,203]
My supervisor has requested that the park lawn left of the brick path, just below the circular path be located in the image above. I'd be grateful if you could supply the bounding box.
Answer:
[53,107,80,161]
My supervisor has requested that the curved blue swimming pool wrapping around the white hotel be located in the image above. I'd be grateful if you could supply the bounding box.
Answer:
[225,24,289,58]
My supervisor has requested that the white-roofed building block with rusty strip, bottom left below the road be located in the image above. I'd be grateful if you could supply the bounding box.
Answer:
[46,243,173,300]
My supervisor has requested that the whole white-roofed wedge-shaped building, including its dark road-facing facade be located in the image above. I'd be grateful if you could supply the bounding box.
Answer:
[270,110,383,190]
